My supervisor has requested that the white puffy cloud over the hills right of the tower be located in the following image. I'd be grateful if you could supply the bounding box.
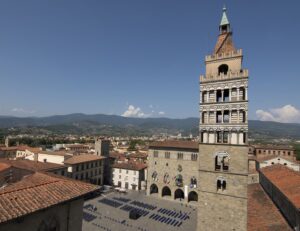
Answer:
[256,104,300,123]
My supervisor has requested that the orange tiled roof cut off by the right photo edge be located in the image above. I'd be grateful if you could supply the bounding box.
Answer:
[260,164,300,208]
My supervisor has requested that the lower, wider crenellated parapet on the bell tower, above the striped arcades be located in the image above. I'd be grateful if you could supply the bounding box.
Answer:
[200,69,249,83]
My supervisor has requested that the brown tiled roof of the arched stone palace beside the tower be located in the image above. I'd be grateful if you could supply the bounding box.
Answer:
[149,140,199,150]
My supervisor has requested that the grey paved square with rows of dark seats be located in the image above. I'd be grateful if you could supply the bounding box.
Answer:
[82,191,197,231]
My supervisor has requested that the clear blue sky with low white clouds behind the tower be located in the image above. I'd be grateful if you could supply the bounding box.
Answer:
[0,0,300,122]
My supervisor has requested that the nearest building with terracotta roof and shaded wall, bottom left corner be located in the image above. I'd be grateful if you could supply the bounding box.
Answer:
[0,170,99,231]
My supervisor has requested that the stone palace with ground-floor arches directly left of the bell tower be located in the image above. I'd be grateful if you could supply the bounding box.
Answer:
[147,140,199,202]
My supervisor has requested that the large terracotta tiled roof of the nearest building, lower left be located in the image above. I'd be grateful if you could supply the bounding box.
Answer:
[0,172,98,223]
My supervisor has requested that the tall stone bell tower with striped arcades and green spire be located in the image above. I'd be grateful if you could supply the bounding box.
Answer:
[197,7,248,231]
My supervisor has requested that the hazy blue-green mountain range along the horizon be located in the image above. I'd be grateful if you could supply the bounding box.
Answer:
[0,113,300,140]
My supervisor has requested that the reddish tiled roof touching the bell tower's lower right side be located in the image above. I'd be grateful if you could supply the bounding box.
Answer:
[248,184,292,231]
